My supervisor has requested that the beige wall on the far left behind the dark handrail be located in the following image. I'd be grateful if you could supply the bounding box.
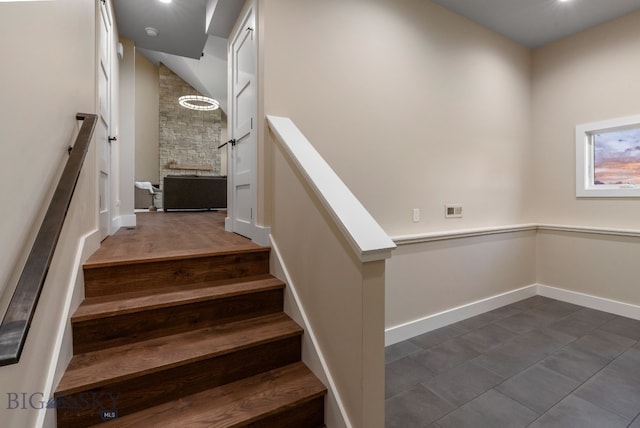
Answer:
[0,0,97,427]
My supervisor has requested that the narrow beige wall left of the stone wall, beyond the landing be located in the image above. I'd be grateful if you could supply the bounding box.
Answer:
[135,52,160,184]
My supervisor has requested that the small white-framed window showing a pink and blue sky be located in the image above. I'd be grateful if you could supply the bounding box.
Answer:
[576,116,640,198]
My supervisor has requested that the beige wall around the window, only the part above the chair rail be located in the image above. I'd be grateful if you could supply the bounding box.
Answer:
[531,12,640,229]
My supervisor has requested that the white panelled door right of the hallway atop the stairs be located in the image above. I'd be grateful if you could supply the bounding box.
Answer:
[229,7,257,238]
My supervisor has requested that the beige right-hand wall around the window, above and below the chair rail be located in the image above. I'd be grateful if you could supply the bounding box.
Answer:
[531,13,640,305]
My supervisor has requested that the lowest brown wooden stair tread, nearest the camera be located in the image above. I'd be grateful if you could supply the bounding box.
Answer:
[90,362,326,428]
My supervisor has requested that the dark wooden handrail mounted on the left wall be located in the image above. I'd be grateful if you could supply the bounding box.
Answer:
[0,113,97,366]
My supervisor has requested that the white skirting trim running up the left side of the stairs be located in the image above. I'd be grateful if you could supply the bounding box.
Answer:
[36,229,100,427]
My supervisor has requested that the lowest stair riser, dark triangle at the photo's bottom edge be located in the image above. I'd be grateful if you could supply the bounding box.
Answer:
[245,396,324,428]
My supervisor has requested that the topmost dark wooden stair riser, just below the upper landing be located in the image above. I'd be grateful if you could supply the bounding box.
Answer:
[84,251,269,297]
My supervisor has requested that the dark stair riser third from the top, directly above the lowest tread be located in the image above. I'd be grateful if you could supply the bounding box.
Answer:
[57,336,304,428]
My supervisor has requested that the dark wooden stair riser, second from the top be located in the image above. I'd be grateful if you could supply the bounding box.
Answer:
[73,289,283,354]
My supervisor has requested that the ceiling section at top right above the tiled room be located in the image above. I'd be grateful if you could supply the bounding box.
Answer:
[432,0,640,48]
